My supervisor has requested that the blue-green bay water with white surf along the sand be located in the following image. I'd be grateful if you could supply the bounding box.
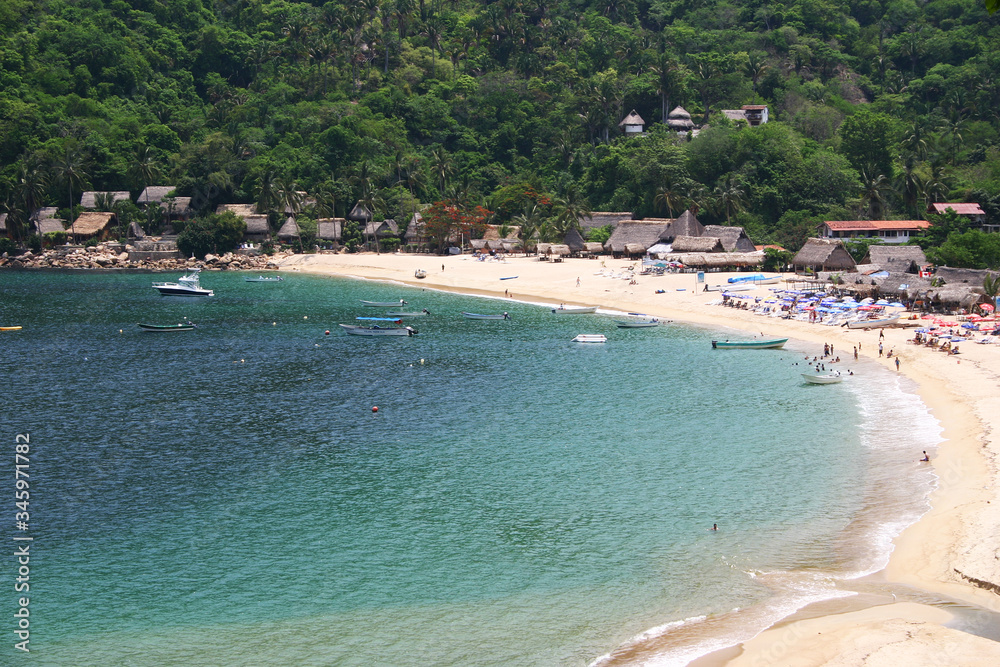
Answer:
[0,272,939,665]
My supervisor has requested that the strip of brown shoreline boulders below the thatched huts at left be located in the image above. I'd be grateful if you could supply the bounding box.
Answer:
[0,244,287,271]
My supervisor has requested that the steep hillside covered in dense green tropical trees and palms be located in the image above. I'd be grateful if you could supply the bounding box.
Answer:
[0,0,1000,266]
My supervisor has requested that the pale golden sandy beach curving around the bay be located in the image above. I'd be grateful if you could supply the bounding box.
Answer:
[280,254,1000,667]
